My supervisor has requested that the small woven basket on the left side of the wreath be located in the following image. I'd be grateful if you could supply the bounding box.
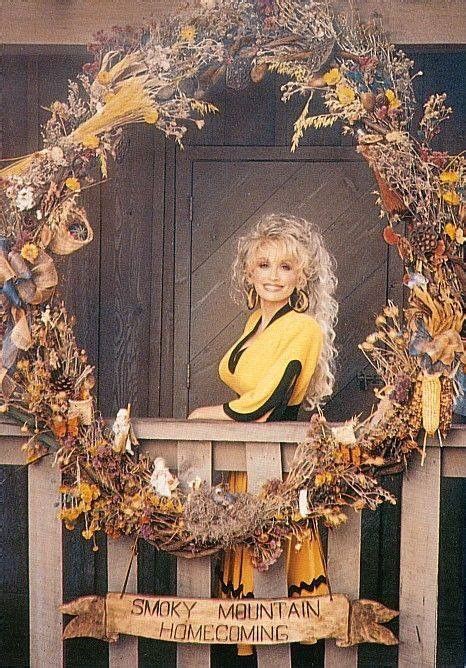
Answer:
[49,199,94,255]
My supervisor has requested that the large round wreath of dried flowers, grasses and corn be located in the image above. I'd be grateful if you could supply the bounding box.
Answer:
[0,0,466,569]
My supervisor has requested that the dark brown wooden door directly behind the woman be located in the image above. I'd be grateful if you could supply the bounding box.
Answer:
[175,147,388,420]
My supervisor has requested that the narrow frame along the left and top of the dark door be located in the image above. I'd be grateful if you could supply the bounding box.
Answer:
[173,146,363,419]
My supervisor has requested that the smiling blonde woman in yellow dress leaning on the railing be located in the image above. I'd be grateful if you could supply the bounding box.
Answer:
[189,215,337,653]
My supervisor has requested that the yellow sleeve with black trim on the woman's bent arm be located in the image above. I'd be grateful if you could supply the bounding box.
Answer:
[223,324,322,422]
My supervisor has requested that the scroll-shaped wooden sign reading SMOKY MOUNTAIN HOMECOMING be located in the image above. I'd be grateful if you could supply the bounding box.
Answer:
[61,593,398,647]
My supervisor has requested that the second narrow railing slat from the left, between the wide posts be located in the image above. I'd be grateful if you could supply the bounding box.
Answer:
[176,441,212,668]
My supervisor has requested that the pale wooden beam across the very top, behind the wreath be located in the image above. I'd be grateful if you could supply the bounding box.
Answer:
[0,0,464,44]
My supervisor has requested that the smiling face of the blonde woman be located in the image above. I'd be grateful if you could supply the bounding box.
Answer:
[249,242,298,308]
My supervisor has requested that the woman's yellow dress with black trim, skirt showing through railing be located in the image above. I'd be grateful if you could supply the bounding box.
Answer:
[219,304,328,654]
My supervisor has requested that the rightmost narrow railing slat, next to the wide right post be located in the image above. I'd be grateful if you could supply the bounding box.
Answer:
[325,512,361,668]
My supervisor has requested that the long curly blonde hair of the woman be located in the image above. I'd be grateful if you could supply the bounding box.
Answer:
[231,214,338,410]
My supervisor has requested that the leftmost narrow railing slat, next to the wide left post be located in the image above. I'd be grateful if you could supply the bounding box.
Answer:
[107,536,138,668]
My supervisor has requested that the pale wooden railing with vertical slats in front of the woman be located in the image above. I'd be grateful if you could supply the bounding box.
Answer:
[0,419,466,668]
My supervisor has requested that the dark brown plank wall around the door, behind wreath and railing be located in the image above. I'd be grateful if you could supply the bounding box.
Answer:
[0,47,465,667]
